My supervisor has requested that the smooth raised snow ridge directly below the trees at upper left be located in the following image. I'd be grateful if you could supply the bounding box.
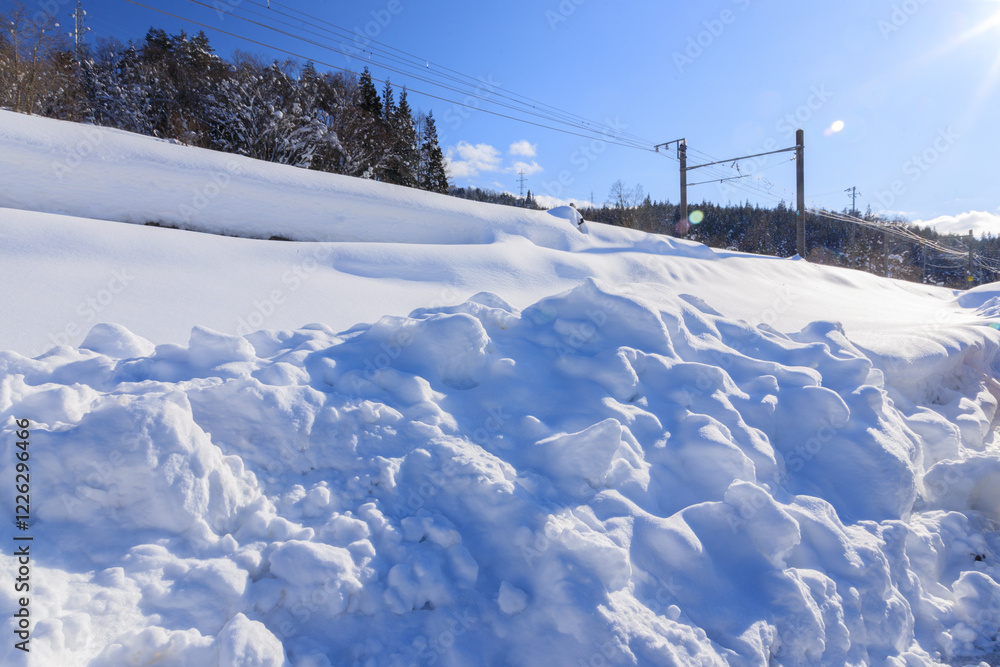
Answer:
[0,110,579,247]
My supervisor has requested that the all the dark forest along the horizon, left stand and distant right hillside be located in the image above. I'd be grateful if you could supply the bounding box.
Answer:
[0,4,1000,287]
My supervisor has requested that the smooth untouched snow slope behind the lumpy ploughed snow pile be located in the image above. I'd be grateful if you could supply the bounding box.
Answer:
[0,111,984,357]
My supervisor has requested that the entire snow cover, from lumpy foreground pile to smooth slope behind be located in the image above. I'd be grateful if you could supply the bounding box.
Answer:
[0,112,1000,667]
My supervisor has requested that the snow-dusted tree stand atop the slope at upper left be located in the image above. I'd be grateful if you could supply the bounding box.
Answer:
[0,4,449,193]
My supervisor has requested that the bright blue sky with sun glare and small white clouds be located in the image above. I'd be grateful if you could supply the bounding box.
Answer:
[7,0,1000,233]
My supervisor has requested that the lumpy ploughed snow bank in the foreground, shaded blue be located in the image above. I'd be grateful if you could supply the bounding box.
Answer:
[0,280,1000,665]
